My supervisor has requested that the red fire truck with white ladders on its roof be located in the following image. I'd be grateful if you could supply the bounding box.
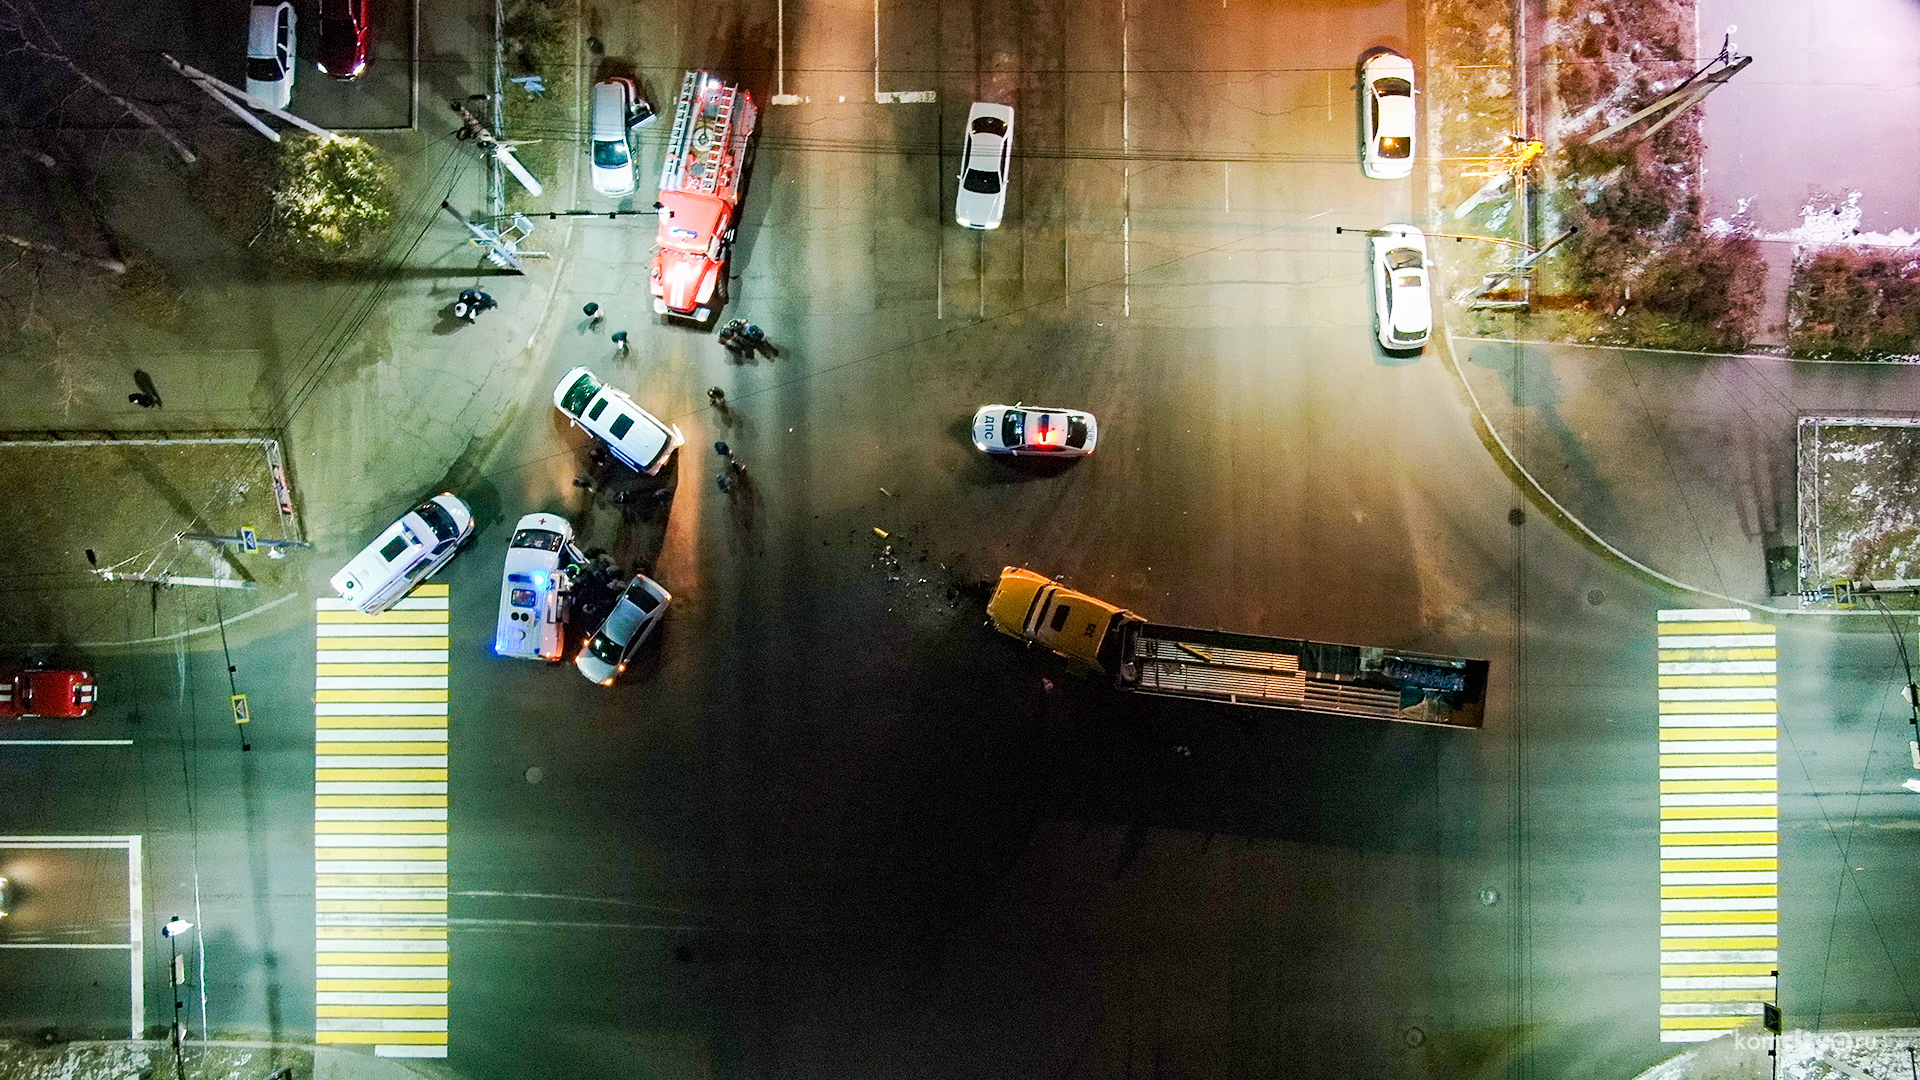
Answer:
[647,71,758,323]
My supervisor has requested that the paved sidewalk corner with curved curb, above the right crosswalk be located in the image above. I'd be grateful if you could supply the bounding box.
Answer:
[1448,338,1920,603]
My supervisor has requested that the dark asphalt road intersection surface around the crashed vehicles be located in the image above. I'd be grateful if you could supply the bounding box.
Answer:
[0,0,1920,1076]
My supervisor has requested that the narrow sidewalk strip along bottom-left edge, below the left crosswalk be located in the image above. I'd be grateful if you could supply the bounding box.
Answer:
[0,1040,447,1080]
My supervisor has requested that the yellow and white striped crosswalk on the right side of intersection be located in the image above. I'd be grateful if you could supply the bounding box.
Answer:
[1659,607,1780,1042]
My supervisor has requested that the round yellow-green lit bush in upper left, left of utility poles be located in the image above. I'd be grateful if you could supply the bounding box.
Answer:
[267,135,396,263]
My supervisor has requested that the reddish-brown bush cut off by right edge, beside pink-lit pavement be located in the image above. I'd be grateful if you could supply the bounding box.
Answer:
[1788,248,1920,359]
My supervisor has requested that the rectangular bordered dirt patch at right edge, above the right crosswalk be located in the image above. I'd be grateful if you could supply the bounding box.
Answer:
[1799,417,1920,590]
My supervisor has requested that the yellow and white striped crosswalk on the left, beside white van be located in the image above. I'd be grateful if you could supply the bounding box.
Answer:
[313,584,447,1057]
